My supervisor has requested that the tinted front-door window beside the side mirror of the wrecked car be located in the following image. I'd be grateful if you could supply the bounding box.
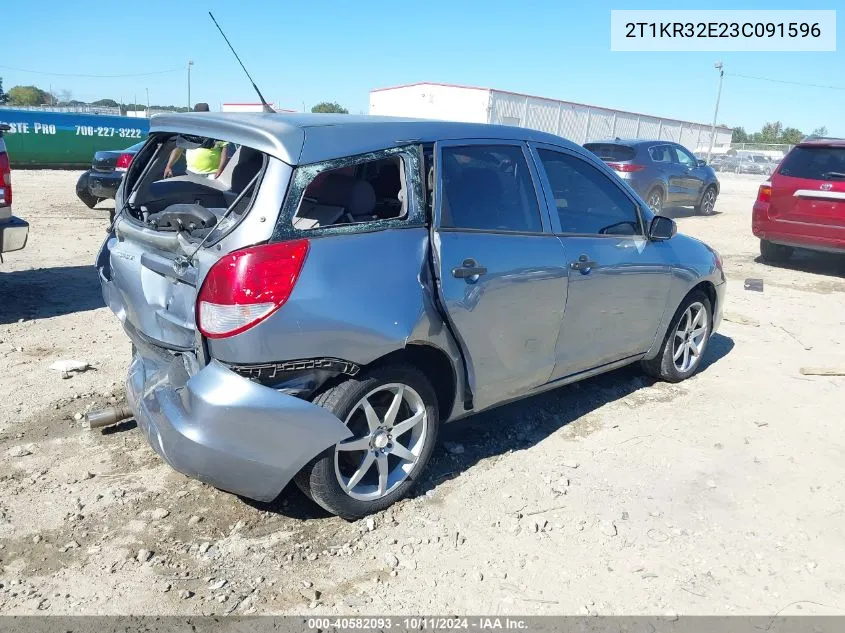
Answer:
[537,149,642,235]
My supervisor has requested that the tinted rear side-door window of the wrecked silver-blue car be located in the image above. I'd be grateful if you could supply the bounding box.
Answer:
[440,145,543,233]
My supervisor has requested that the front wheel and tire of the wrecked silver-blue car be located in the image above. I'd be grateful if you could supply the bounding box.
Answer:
[641,290,713,382]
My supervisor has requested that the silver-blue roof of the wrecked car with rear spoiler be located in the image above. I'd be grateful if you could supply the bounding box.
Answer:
[150,112,583,165]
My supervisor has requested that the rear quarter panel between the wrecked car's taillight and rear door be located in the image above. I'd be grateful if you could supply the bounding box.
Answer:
[208,227,457,365]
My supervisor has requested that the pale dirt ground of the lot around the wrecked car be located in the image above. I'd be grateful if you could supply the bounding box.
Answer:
[0,171,845,614]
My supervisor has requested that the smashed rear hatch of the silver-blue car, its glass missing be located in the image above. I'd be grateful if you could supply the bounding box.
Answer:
[97,133,284,350]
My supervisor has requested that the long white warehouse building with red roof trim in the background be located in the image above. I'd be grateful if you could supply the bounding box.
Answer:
[370,82,731,154]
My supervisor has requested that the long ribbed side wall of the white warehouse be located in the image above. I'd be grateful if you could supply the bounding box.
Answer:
[490,90,732,153]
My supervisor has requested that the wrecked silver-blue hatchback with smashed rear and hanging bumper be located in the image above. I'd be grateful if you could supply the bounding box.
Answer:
[97,113,725,518]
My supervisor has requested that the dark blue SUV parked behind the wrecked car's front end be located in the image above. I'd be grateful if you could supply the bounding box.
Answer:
[584,138,719,215]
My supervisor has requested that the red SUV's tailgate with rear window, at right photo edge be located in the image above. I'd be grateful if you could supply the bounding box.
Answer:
[769,145,845,229]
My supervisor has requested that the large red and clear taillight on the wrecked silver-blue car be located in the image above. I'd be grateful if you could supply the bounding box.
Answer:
[197,240,308,338]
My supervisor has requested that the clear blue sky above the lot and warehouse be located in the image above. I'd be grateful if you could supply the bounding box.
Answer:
[0,0,845,136]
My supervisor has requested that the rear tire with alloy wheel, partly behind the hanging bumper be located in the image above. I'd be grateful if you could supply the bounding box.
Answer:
[294,364,440,520]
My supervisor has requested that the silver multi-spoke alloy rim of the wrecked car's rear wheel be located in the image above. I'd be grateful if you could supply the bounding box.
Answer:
[334,383,428,501]
